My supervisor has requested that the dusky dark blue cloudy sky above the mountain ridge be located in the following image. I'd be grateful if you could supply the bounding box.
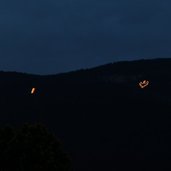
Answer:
[0,0,171,74]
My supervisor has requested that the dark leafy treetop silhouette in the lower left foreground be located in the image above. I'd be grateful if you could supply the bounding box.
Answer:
[0,124,72,171]
